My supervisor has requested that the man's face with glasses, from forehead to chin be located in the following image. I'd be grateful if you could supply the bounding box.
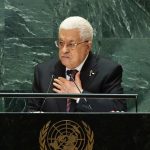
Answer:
[59,29,91,69]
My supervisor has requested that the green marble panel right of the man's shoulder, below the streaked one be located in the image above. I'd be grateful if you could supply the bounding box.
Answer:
[101,38,150,112]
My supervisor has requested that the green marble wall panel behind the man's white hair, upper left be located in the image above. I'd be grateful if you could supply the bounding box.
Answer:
[5,0,101,38]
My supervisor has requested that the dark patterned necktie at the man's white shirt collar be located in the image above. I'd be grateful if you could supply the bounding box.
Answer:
[66,69,78,112]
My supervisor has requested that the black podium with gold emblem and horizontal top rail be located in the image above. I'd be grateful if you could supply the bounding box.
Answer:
[0,93,150,150]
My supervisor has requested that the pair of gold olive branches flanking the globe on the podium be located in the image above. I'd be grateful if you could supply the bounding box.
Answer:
[39,121,94,150]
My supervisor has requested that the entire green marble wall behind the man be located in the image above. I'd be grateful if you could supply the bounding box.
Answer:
[0,0,150,112]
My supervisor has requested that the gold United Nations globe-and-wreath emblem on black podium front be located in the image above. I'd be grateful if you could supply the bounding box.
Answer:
[39,120,94,150]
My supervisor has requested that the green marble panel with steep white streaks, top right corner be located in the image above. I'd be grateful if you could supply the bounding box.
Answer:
[102,0,150,38]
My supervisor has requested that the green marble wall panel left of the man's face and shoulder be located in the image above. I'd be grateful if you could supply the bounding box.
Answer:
[3,38,57,90]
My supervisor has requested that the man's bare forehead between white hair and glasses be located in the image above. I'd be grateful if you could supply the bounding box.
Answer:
[58,28,81,42]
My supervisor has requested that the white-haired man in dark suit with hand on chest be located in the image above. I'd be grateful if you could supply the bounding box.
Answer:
[28,16,126,112]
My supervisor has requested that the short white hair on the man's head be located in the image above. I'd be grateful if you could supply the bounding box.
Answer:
[59,16,93,41]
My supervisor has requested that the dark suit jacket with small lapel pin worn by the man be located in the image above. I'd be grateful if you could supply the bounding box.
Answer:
[28,52,126,112]
